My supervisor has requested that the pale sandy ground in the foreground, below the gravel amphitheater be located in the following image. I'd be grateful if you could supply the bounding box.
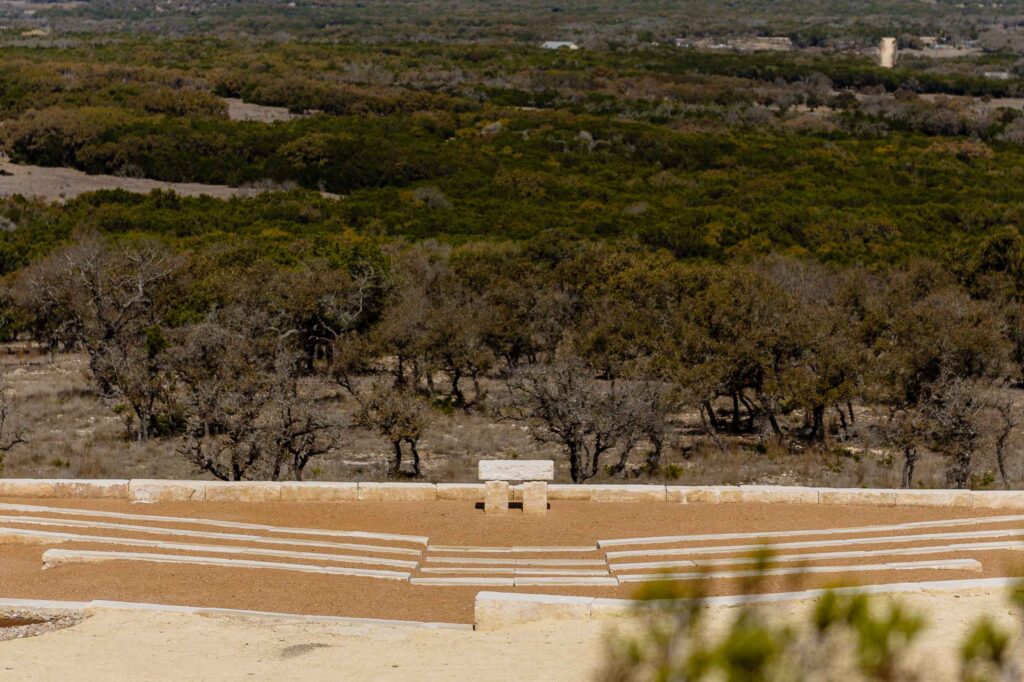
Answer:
[0,590,1017,682]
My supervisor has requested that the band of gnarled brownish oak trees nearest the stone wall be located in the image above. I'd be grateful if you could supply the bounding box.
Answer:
[2,231,1024,487]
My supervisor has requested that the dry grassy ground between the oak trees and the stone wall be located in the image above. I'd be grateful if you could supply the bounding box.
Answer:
[0,346,1024,487]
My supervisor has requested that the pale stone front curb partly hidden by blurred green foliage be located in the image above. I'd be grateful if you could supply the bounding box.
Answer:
[473,578,1021,631]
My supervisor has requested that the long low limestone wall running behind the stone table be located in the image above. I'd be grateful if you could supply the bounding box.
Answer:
[0,478,1024,509]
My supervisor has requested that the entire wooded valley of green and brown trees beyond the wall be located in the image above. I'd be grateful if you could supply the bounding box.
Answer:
[0,1,1024,487]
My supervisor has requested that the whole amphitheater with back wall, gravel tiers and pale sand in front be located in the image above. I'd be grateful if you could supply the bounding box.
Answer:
[0,479,1024,680]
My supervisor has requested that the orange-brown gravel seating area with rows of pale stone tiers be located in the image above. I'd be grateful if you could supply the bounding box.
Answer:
[0,499,1024,623]
